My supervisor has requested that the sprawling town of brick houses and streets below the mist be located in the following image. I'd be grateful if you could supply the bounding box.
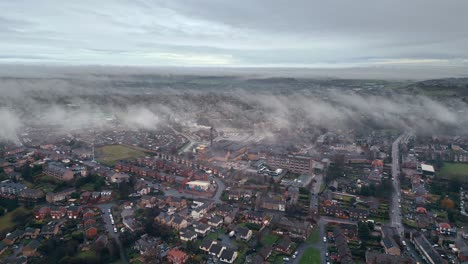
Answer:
[0,117,468,264]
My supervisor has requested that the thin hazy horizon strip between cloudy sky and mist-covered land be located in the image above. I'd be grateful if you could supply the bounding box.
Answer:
[0,63,468,81]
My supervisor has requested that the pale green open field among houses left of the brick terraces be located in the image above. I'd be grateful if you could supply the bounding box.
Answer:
[96,145,150,166]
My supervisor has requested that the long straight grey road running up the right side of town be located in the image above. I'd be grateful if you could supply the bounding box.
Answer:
[390,134,408,236]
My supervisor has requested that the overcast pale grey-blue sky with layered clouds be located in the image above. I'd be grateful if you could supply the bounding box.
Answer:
[0,0,468,69]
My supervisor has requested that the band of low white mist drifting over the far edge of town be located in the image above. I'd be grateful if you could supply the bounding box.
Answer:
[0,70,468,142]
